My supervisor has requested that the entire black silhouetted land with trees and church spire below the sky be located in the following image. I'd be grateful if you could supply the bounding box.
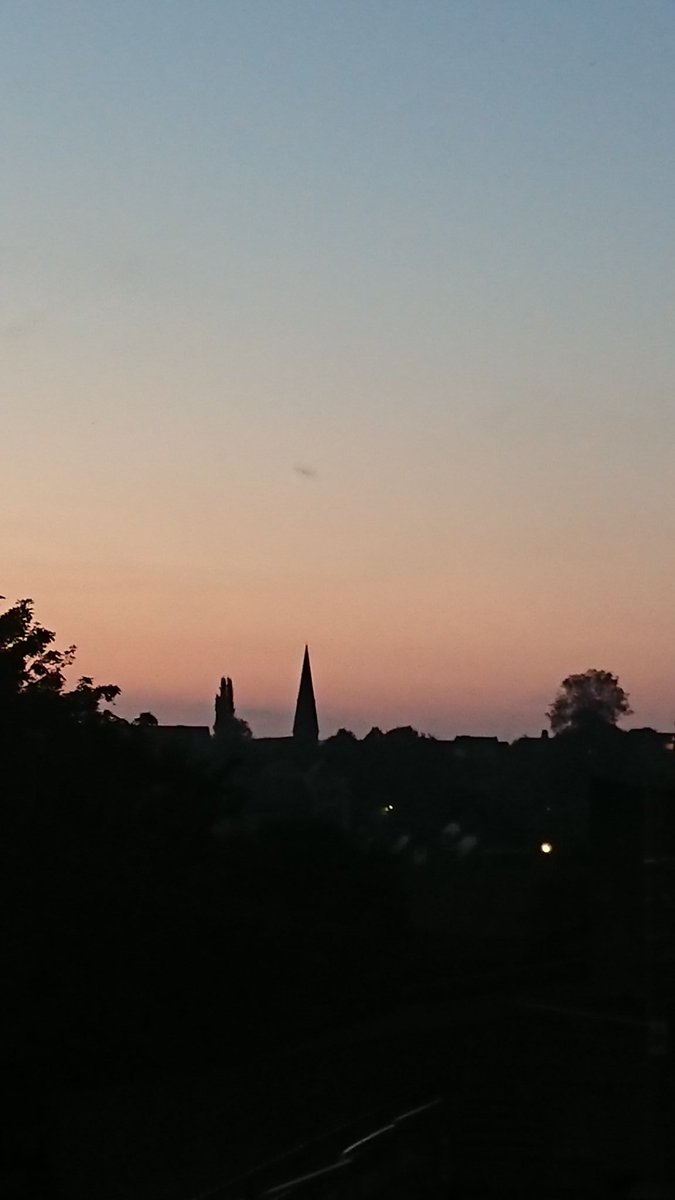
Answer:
[5,588,675,1200]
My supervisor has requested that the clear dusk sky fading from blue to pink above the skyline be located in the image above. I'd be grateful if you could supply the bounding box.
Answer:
[0,0,675,739]
